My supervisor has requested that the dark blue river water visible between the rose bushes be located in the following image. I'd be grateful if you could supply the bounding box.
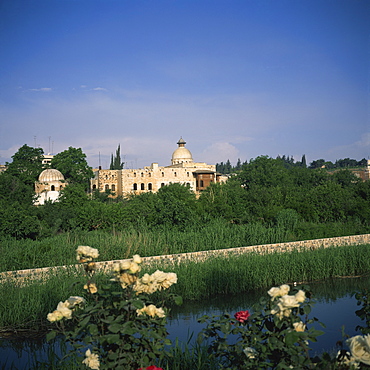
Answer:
[0,277,370,370]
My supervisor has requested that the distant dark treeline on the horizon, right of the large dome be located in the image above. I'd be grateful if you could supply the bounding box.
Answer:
[216,155,367,175]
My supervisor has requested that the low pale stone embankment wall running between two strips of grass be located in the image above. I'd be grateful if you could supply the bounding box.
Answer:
[0,234,370,283]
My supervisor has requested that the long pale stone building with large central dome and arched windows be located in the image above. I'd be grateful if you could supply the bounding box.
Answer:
[91,138,227,196]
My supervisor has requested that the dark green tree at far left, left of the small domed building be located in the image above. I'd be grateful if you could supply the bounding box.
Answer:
[6,144,44,187]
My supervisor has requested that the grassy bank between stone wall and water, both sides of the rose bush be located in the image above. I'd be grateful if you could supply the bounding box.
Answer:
[0,245,370,330]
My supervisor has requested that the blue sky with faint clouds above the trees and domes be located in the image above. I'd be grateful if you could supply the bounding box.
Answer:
[0,0,370,168]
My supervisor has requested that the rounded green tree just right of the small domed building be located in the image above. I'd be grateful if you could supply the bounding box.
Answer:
[51,146,94,190]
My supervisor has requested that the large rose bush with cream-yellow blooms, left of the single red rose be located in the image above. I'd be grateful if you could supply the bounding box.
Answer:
[47,246,182,370]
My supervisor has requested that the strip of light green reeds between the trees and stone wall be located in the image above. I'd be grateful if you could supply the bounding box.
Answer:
[0,220,366,271]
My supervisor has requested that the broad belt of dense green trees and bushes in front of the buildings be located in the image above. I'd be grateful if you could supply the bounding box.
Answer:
[0,146,370,239]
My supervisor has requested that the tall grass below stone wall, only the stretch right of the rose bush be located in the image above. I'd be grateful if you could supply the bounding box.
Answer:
[152,245,370,300]
